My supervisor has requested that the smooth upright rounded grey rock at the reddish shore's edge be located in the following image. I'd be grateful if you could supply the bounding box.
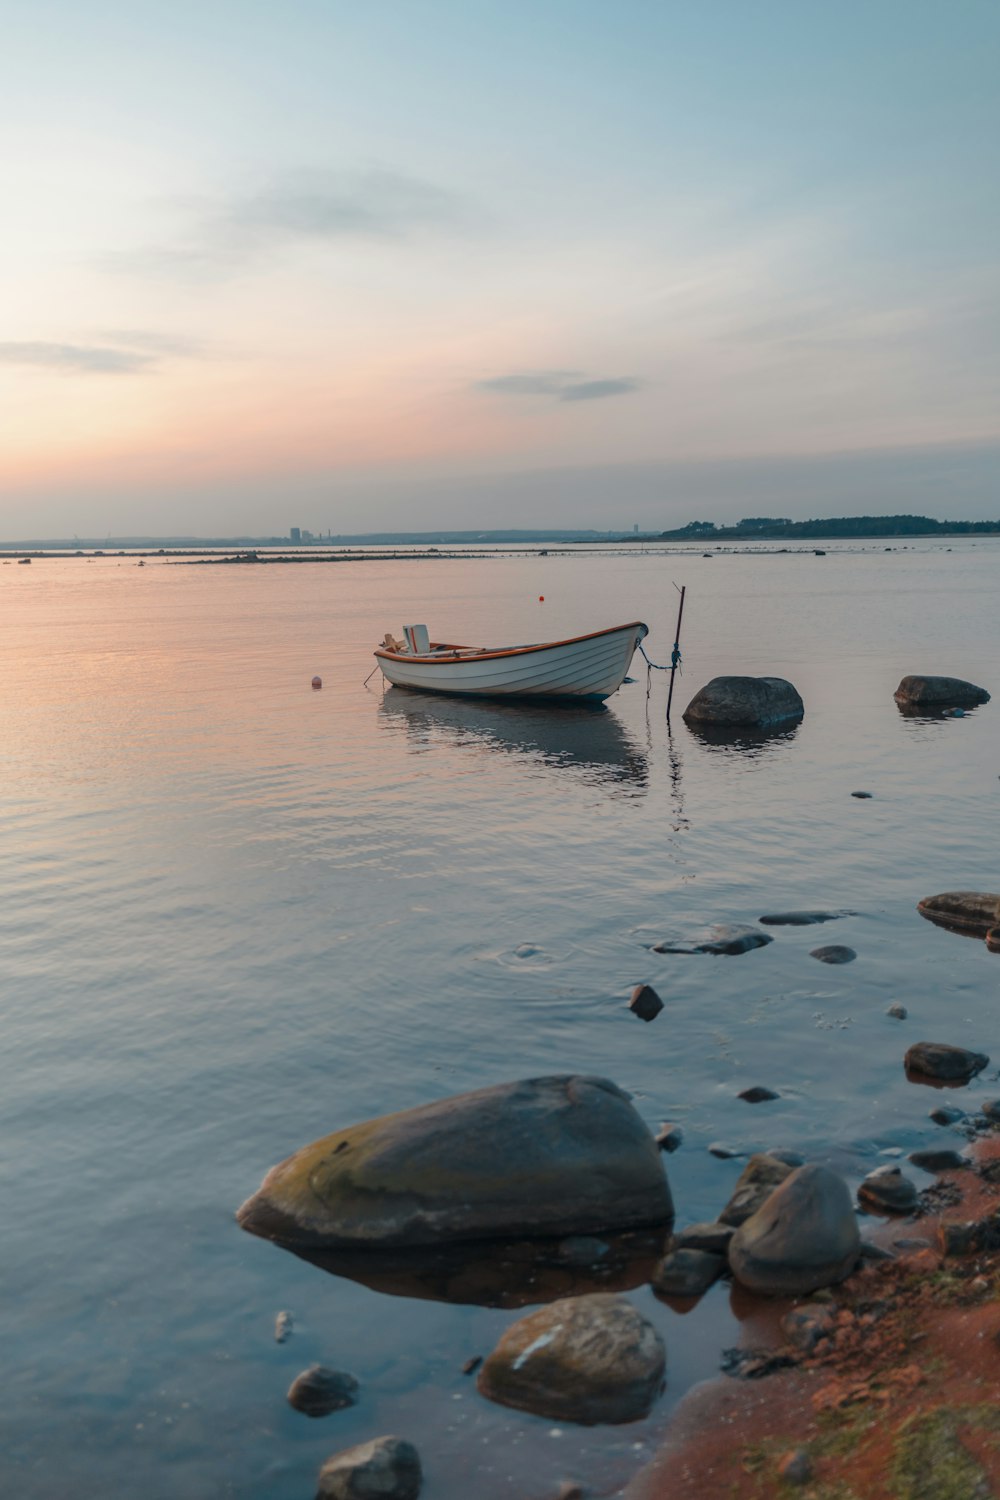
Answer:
[729,1166,861,1296]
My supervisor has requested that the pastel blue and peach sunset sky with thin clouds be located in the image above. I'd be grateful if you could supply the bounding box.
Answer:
[0,0,1000,539]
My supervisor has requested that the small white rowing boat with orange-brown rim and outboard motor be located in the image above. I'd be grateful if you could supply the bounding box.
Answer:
[375,620,649,701]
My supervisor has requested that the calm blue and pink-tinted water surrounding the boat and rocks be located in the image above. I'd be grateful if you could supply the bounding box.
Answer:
[0,542,1000,1500]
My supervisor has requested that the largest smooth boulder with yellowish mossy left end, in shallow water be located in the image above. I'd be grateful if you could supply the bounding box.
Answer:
[237,1074,673,1248]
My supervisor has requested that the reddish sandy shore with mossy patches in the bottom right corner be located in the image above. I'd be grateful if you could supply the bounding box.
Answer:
[625,1137,1000,1500]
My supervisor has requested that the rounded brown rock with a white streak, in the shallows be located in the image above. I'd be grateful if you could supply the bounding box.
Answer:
[478,1293,666,1425]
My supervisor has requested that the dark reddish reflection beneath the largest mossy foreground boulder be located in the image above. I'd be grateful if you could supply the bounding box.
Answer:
[292,1224,670,1308]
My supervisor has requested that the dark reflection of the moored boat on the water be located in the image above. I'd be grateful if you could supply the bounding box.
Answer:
[379,687,649,794]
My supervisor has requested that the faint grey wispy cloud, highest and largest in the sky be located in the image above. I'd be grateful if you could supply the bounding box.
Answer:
[102,168,474,278]
